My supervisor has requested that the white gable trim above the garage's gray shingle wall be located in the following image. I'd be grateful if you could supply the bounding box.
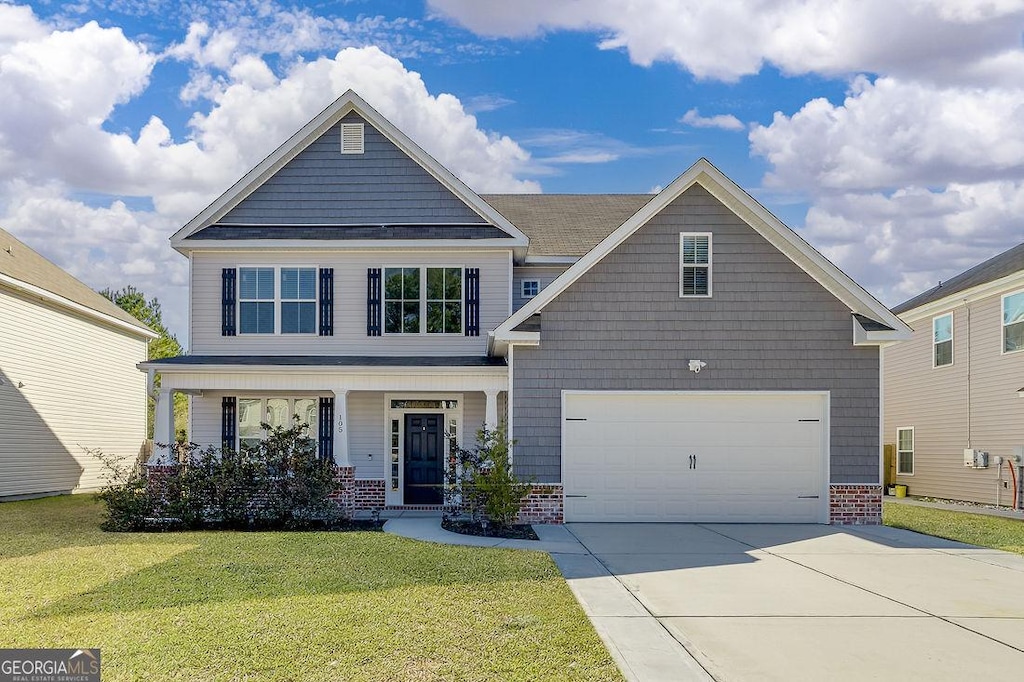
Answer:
[490,159,910,342]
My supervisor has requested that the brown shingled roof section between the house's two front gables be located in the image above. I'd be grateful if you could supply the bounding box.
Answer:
[480,195,654,258]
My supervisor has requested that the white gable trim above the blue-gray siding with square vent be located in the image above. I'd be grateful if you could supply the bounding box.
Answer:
[171,90,528,252]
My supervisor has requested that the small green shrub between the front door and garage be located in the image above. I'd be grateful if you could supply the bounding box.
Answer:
[445,424,532,525]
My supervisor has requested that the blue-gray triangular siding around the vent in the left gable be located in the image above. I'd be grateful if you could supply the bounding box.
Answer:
[220,113,484,225]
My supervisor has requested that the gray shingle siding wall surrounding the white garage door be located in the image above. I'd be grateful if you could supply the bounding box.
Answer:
[513,185,879,483]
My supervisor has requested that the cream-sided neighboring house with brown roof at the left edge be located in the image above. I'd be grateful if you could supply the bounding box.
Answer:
[0,229,157,499]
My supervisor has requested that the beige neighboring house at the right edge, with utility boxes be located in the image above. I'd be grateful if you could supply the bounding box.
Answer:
[884,244,1024,505]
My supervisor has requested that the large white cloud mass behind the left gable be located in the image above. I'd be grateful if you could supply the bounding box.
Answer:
[0,4,539,339]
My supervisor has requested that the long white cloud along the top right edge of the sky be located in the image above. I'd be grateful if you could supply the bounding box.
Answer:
[429,0,1024,81]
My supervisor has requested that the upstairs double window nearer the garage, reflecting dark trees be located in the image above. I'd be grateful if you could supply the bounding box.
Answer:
[384,267,463,334]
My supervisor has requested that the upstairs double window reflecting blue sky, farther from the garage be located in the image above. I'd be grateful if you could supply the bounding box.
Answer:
[239,267,316,334]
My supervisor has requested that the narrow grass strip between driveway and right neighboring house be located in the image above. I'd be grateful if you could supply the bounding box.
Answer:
[882,502,1024,554]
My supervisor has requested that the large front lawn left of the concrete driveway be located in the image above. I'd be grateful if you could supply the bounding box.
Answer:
[0,496,622,681]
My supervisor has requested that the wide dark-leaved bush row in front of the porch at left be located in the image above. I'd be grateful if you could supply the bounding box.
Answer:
[94,421,344,530]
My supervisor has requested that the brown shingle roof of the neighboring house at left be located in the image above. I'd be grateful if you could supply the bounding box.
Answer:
[0,228,148,329]
